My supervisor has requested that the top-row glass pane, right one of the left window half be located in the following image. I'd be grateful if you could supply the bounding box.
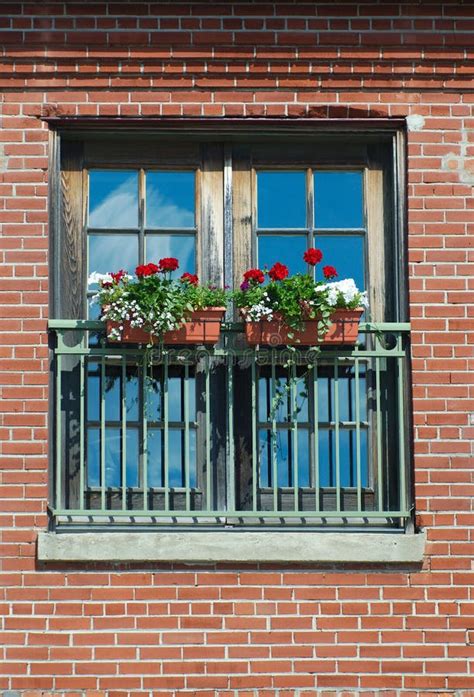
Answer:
[146,172,195,228]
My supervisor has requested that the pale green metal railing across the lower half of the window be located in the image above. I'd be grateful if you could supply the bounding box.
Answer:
[49,320,410,527]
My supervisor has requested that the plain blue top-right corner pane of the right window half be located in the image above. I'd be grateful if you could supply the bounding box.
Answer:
[314,172,364,228]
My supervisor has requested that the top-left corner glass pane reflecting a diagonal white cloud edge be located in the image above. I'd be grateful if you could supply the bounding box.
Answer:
[89,170,138,228]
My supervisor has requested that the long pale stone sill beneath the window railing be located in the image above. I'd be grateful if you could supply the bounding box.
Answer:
[38,530,425,564]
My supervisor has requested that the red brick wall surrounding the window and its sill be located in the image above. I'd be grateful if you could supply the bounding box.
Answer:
[0,0,474,697]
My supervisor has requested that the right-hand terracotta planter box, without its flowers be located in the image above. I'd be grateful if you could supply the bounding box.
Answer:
[243,308,364,346]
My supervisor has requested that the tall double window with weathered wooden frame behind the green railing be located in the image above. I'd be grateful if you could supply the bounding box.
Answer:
[51,126,410,526]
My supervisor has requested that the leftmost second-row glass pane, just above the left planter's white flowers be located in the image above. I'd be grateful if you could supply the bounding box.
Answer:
[88,234,138,290]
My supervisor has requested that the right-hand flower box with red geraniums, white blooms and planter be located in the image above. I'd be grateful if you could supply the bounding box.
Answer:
[233,248,367,346]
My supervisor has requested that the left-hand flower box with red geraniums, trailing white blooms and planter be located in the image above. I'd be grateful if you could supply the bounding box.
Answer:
[89,257,230,344]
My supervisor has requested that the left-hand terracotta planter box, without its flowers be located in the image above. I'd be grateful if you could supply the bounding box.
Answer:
[107,307,226,344]
